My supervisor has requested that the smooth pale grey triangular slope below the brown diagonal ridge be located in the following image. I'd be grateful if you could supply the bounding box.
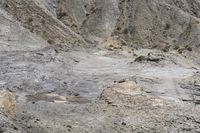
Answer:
[0,9,47,52]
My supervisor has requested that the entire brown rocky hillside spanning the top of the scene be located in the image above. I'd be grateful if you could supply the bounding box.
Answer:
[1,0,200,49]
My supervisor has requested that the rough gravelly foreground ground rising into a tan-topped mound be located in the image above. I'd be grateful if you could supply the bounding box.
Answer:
[11,81,200,133]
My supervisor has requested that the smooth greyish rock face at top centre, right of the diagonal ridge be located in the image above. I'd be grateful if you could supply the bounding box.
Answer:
[57,0,120,38]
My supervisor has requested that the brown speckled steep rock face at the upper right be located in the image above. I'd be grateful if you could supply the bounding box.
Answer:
[114,0,200,47]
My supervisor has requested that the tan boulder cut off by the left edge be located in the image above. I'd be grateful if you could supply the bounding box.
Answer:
[0,90,16,118]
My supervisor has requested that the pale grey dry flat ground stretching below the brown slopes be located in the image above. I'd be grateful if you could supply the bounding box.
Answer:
[0,47,200,133]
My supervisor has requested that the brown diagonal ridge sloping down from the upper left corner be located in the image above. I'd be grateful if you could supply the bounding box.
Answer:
[0,0,85,50]
